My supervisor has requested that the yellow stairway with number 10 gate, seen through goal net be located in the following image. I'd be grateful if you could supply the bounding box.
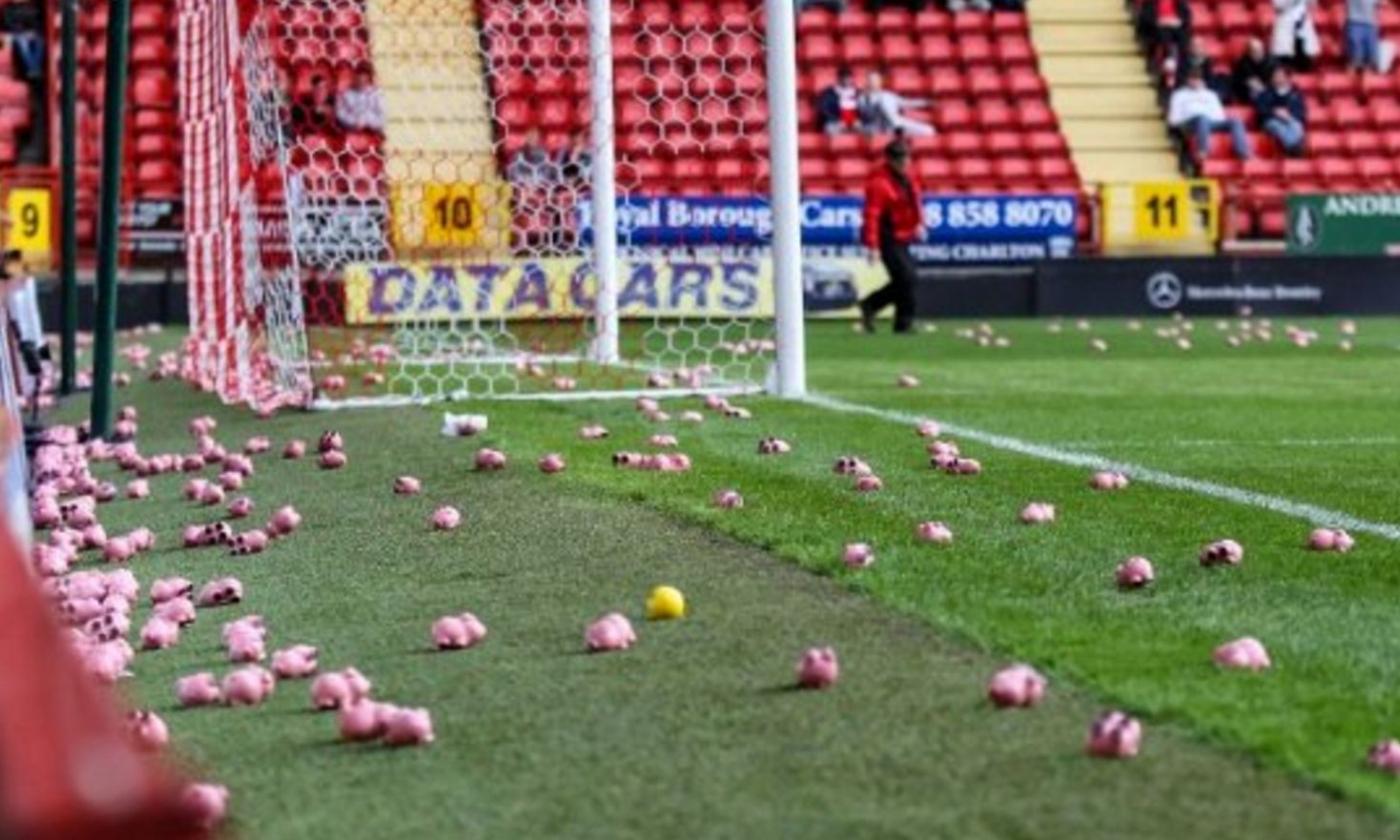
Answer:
[365,0,510,258]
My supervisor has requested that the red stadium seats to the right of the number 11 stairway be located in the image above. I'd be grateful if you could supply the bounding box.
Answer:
[1142,0,1400,239]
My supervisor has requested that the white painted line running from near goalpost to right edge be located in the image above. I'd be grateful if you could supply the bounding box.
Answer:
[804,393,1400,542]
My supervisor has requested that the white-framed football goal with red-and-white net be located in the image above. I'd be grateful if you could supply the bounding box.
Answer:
[179,0,805,410]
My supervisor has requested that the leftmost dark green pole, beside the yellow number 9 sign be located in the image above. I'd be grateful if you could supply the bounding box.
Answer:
[59,0,78,395]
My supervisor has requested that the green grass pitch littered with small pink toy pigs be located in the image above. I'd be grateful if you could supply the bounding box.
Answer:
[60,321,1400,837]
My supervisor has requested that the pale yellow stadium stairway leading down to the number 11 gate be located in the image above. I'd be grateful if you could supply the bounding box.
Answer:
[1026,0,1214,253]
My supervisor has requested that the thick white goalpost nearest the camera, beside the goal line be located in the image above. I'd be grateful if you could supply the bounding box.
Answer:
[764,0,806,399]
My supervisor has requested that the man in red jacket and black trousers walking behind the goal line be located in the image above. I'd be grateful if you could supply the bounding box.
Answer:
[861,137,924,333]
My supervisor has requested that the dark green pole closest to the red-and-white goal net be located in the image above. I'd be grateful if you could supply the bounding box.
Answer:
[91,0,132,438]
